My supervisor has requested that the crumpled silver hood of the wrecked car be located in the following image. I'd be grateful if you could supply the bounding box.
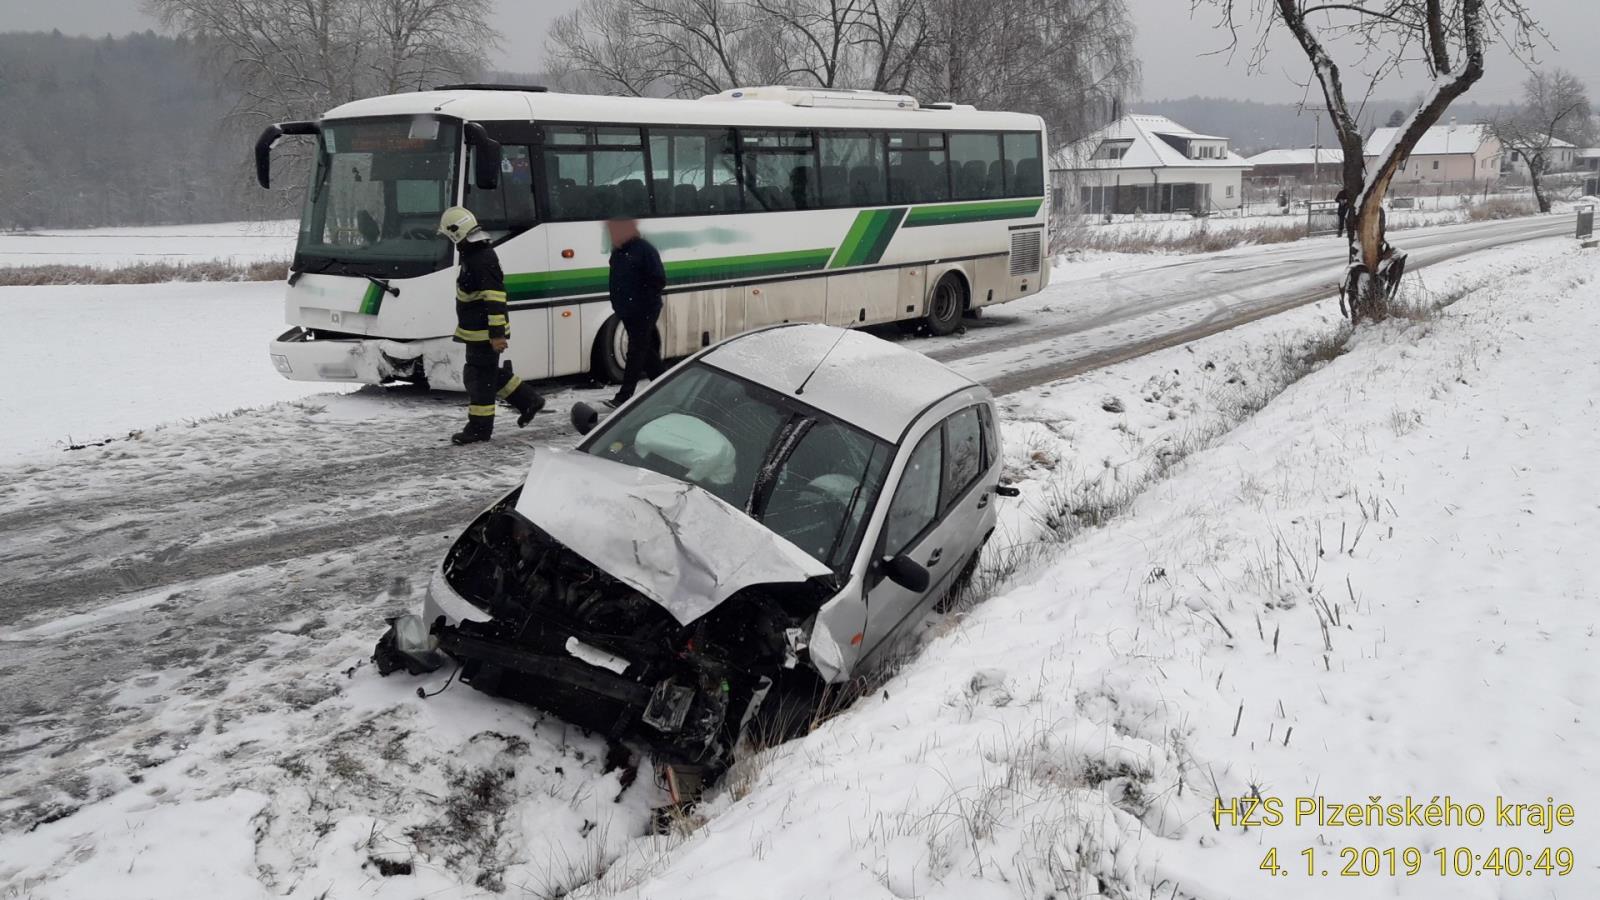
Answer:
[517,448,832,625]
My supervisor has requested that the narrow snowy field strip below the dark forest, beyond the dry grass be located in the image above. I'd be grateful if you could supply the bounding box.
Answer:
[0,221,296,269]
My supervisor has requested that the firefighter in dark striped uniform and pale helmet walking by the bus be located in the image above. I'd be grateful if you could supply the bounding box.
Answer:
[438,207,544,444]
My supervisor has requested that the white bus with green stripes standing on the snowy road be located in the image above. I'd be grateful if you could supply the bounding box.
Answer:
[256,85,1050,389]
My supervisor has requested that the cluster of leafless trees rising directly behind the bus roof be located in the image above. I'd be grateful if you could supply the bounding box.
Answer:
[547,0,1138,143]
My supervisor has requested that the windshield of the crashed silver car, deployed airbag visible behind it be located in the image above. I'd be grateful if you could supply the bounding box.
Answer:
[586,364,893,570]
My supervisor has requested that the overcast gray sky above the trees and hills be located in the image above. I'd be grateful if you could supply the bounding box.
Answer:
[0,0,1600,102]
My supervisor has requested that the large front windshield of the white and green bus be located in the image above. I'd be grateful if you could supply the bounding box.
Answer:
[293,115,461,277]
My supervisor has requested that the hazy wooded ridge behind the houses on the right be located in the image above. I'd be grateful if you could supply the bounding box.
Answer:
[1128,96,1494,157]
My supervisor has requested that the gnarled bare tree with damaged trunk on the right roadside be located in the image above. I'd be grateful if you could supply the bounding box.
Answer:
[1192,0,1542,322]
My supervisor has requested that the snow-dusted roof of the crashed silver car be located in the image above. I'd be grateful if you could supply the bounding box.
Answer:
[701,323,982,444]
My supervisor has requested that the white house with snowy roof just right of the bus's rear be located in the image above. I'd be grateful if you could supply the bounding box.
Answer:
[1050,114,1250,215]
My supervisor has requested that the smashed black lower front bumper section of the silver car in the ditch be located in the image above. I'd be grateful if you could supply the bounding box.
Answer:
[434,621,745,765]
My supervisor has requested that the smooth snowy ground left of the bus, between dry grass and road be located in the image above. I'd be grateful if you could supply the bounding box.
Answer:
[0,283,347,461]
